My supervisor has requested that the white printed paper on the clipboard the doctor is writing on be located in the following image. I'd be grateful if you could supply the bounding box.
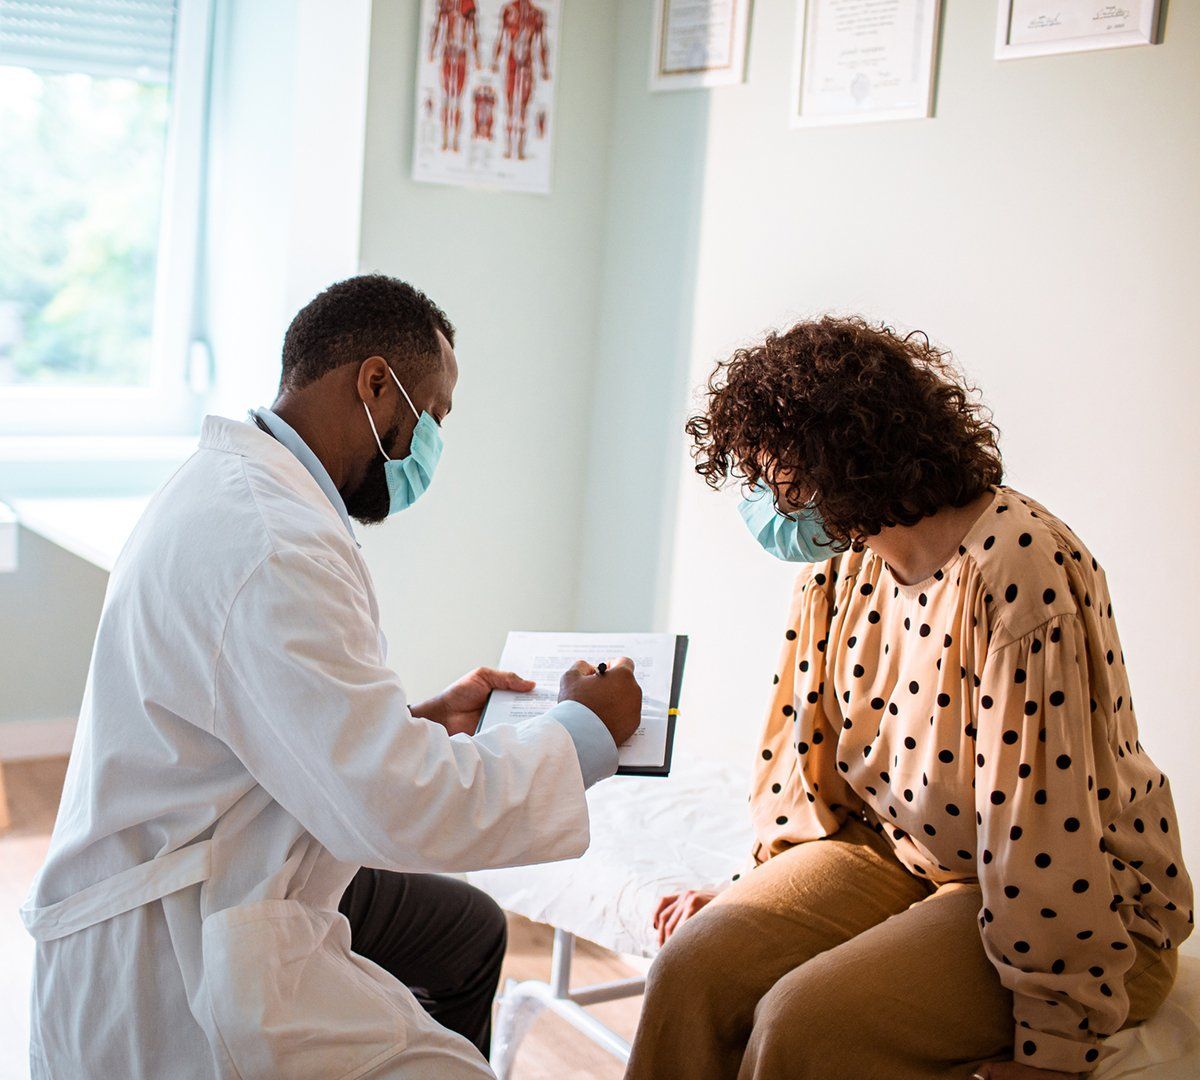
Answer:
[479,630,676,768]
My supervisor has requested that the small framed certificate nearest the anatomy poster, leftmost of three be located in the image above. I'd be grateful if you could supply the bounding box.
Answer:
[650,0,750,90]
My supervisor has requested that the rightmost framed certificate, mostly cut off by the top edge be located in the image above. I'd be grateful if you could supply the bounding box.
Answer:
[996,0,1162,60]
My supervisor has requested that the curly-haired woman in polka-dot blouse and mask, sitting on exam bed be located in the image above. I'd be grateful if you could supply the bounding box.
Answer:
[626,318,1193,1080]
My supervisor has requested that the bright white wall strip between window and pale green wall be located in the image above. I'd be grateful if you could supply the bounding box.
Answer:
[200,0,371,419]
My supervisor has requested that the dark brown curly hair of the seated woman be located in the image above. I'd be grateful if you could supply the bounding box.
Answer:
[685,316,1003,547]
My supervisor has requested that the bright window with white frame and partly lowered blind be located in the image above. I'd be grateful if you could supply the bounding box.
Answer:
[0,0,210,433]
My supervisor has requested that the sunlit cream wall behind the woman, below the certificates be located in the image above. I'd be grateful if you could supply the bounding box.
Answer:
[628,0,1200,945]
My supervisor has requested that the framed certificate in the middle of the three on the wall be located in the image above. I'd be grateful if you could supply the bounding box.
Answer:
[792,0,942,127]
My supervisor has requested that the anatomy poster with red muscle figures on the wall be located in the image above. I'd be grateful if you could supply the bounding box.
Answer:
[413,0,562,194]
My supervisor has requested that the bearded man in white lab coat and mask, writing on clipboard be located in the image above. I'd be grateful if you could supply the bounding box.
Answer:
[22,276,641,1080]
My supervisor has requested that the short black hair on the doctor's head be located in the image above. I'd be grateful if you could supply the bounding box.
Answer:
[280,274,454,390]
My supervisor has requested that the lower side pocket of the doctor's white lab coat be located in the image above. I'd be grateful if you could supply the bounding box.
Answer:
[204,900,406,1080]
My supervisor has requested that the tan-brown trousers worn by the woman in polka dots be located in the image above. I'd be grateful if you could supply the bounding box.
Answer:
[625,818,1178,1080]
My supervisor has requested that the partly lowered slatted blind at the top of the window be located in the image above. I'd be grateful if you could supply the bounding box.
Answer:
[0,0,179,83]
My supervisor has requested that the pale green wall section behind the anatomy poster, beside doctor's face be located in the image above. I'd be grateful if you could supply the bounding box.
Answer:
[361,0,614,695]
